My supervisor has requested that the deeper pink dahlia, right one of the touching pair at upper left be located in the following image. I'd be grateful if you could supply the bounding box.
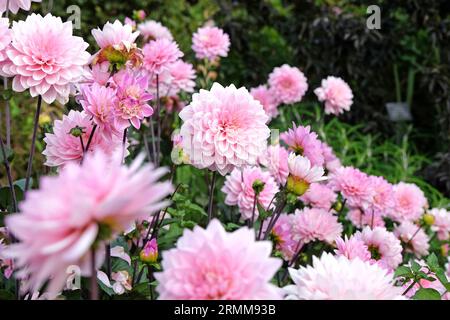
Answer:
[113,69,153,130]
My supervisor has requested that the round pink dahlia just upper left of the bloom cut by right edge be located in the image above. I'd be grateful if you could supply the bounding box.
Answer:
[391,182,428,222]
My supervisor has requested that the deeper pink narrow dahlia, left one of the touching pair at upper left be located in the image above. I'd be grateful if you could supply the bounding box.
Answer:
[80,82,121,139]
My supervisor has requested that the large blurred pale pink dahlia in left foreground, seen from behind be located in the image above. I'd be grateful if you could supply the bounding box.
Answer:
[6,152,172,292]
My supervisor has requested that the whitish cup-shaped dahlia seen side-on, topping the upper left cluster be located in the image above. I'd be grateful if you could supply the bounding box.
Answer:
[92,20,139,49]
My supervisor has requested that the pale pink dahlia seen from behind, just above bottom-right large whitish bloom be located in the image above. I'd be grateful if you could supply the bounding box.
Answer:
[354,227,403,270]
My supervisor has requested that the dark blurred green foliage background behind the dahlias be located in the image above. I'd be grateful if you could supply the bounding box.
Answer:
[2,0,450,202]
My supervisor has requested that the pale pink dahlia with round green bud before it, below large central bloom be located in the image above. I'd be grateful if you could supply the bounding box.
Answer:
[222,167,279,220]
